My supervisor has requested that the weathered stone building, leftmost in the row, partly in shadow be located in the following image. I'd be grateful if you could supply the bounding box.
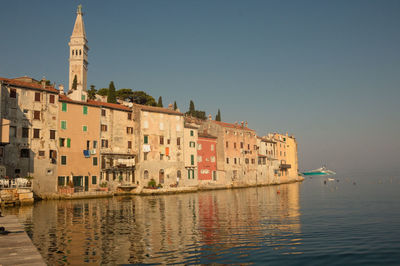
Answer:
[0,77,58,194]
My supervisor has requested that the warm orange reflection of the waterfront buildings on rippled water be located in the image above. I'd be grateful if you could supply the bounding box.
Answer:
[6,183,302,264]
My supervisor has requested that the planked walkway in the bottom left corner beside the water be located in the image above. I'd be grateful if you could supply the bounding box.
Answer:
[0,215,46,265]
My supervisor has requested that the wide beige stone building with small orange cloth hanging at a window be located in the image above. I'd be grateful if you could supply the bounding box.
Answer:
[133,104,185,187]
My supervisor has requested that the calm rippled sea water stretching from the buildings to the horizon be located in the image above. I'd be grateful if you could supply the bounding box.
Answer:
[6,176,400,265]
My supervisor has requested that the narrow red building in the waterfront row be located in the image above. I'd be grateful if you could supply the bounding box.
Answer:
[197,133,217,181]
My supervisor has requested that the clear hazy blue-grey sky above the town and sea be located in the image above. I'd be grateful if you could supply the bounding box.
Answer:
[0,0,400,175]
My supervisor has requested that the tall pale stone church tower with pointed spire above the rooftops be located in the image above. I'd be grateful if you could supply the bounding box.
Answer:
[68,5,89,101]
